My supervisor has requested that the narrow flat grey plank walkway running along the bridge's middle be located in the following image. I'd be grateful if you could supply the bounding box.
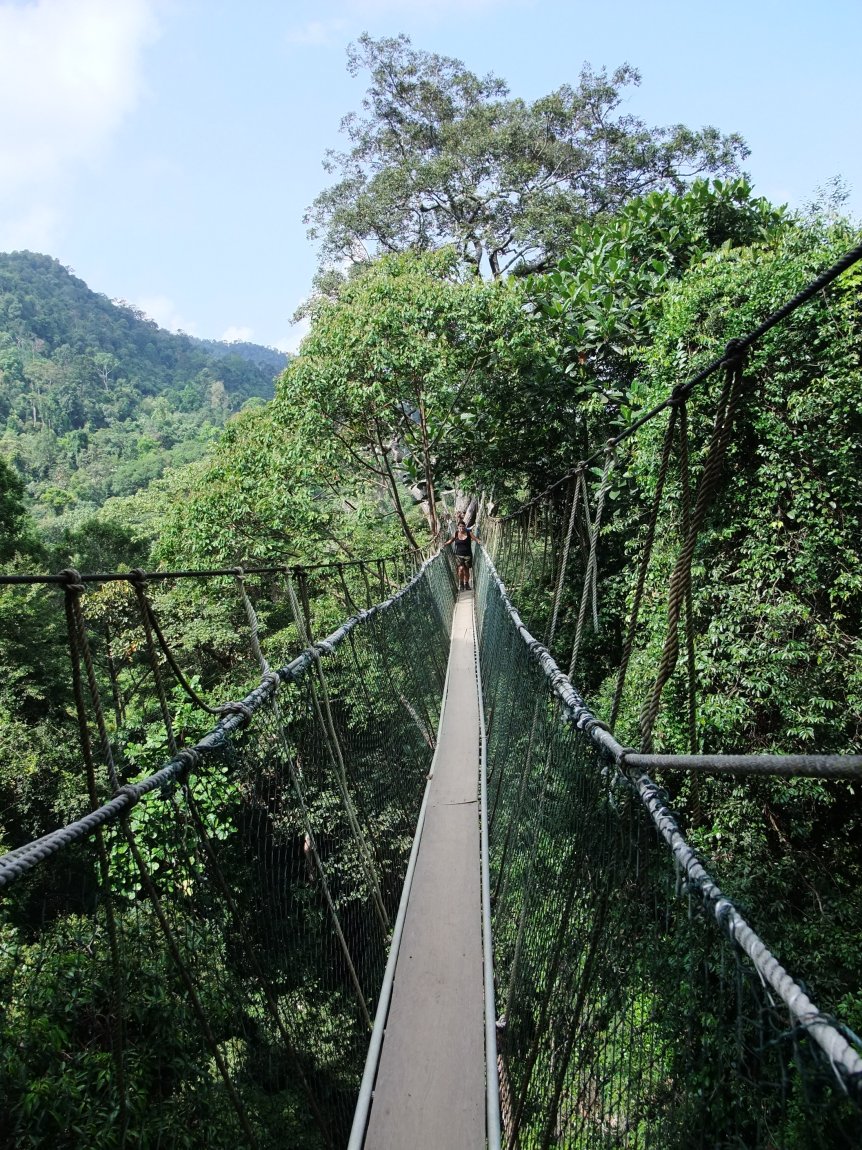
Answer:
[364,593,485,1150]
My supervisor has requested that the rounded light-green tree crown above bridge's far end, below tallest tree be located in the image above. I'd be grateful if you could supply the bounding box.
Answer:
[285,248,564,530]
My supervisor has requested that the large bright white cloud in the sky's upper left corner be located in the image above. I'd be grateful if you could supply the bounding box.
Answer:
[0,0,157,246]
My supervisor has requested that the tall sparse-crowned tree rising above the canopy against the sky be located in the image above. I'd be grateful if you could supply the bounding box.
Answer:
[305,33,748,278]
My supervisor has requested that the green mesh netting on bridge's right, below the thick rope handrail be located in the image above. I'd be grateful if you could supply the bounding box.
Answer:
[477,553,862,1150]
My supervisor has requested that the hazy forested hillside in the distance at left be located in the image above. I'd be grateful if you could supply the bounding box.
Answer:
[0,252,287,526]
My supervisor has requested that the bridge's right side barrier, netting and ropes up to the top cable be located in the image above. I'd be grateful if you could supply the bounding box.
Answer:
[477,238,862,1150]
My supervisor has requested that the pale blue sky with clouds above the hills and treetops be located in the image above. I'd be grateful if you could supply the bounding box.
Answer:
[0,0,862,350]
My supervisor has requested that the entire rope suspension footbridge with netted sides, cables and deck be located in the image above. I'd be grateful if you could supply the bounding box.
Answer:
[0,238,862,1150]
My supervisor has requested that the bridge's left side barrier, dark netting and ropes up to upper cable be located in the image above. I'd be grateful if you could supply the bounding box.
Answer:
[0,555,453,1150]
